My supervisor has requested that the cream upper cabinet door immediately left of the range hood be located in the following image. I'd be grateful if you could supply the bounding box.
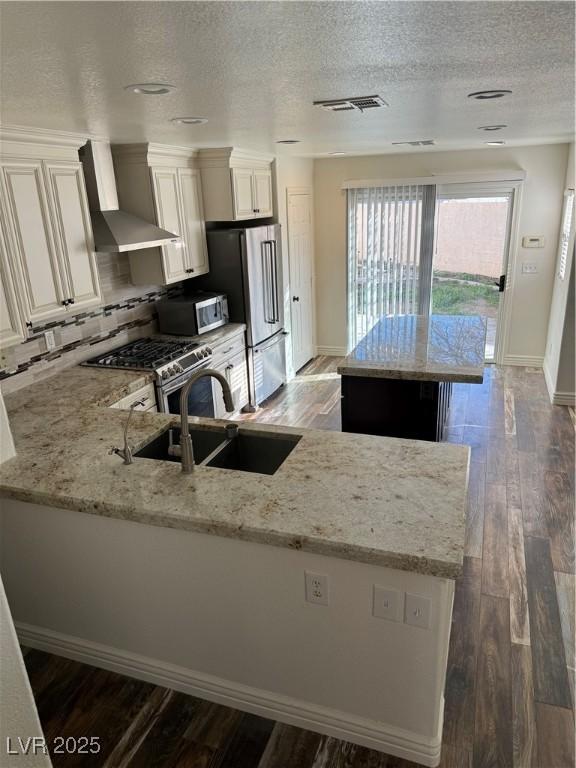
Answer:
[45,163,101,309]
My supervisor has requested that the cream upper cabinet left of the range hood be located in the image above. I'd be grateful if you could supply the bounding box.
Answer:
[0,129,101,345]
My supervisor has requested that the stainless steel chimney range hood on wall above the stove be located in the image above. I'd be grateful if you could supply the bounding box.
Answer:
[80,141,180,253]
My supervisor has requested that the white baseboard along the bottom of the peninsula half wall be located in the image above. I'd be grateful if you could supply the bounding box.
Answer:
[16,622,443,768]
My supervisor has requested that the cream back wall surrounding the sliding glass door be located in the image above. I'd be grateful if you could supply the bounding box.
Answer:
[314,144,568,364]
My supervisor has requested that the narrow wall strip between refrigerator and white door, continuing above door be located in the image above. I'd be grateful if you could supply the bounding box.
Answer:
[274,157,314,380]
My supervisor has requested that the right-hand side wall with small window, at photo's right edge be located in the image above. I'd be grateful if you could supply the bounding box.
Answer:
[544,144,576,405]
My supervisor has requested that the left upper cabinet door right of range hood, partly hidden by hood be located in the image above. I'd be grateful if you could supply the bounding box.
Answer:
[151,168,190,283]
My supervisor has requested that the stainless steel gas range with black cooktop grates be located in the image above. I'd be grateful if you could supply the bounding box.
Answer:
[83,338,220,418]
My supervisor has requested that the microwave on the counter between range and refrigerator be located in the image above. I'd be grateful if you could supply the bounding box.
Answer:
[156,291,228,336]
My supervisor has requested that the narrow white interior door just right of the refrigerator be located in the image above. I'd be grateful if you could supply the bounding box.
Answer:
[287,190,314,371]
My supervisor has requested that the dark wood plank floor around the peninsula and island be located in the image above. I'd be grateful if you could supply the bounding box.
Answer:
[20,358,575,768]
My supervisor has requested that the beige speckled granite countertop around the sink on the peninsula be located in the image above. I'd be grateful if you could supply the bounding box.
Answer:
[0,334,469,578]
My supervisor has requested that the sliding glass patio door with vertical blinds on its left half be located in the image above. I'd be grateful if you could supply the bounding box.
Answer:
[348,182,516,361]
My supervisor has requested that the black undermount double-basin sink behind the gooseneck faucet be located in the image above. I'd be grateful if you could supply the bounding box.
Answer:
[134,426,300,475]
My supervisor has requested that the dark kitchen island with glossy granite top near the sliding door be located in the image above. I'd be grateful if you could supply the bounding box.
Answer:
[338,315,486,441]
